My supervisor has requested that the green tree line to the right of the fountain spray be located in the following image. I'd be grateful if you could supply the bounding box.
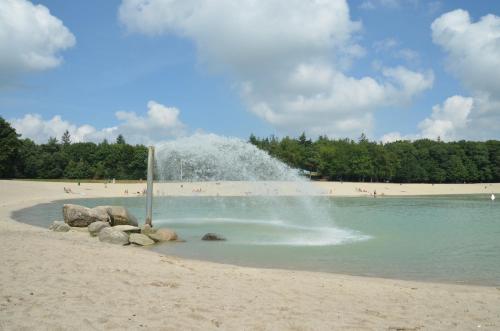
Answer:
[249,134,500,183]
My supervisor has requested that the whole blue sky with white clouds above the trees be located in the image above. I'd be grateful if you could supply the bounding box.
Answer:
[0,0,500,144]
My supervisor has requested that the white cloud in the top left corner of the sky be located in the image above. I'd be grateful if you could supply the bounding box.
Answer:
[0,0,75,84]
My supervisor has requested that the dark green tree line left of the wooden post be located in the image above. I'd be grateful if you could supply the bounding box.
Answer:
[0,117,148,179]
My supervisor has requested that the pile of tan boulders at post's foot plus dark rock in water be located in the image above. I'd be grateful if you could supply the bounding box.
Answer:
[49,204,226,246]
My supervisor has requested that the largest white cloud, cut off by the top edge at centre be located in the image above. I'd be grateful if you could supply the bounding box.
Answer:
[119,0,433,136]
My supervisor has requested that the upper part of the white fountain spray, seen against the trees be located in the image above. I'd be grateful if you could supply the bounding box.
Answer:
[156,134,301,182]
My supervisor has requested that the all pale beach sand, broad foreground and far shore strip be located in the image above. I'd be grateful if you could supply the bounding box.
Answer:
[0,181,500,330]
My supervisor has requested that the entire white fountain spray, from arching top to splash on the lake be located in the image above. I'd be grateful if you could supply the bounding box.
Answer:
[150,134,366,245]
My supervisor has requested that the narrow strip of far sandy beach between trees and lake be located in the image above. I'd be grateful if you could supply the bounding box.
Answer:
[0,181,500,200]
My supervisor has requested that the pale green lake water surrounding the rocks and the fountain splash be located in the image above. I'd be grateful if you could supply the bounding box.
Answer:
[13,195,500,286]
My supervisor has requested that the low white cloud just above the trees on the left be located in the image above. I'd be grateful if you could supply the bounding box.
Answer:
[10,101,185,144]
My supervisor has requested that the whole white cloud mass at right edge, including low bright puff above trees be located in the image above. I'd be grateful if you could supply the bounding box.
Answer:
[382,9,500,141]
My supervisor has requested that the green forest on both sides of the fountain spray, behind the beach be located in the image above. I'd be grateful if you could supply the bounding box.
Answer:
[0,117,500,183]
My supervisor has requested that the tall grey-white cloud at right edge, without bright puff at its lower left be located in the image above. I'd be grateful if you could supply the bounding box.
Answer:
[431,9,500,139]
